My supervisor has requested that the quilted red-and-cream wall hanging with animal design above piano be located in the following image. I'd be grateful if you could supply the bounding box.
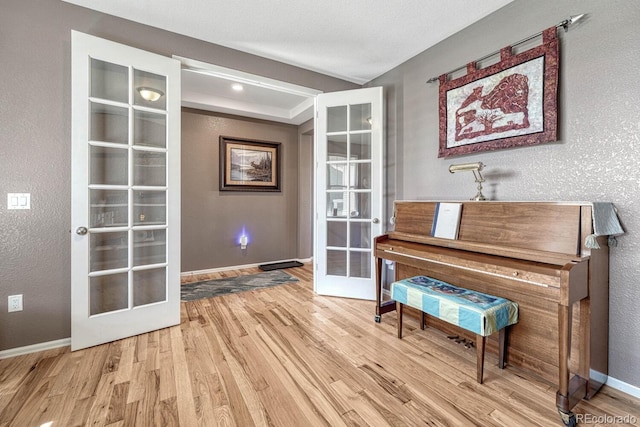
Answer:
[438,27,559,157]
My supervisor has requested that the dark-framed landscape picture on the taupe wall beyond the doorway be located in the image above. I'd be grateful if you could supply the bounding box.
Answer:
[220,136,281,191]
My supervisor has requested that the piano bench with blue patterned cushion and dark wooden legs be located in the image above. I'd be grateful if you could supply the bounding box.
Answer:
[391,276,518,384]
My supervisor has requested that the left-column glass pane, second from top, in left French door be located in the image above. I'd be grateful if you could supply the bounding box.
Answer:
[89,102,129,144]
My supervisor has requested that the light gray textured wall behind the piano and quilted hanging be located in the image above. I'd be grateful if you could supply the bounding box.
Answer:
[368,0,640,386]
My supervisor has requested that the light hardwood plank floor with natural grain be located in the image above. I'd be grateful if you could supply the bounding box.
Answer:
[0,265,640,427]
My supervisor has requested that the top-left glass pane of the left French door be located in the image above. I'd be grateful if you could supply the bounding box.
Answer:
[89,58,129,102]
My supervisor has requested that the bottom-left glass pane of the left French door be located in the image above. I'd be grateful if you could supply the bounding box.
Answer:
[89,273,129,316]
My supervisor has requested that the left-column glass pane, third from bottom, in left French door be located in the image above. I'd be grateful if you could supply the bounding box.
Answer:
[89,190,129,228]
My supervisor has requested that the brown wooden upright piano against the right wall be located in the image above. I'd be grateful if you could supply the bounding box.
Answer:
[374,201,609,417]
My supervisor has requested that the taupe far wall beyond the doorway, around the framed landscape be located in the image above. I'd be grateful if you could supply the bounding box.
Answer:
[181,109,300,271]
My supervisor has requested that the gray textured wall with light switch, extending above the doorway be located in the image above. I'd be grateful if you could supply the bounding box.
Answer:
[0,0,356,351]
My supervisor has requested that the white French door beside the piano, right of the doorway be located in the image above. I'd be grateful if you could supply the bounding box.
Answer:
[314,87,384,300]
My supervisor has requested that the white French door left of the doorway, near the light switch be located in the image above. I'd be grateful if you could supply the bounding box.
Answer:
[71,31,180,350]
